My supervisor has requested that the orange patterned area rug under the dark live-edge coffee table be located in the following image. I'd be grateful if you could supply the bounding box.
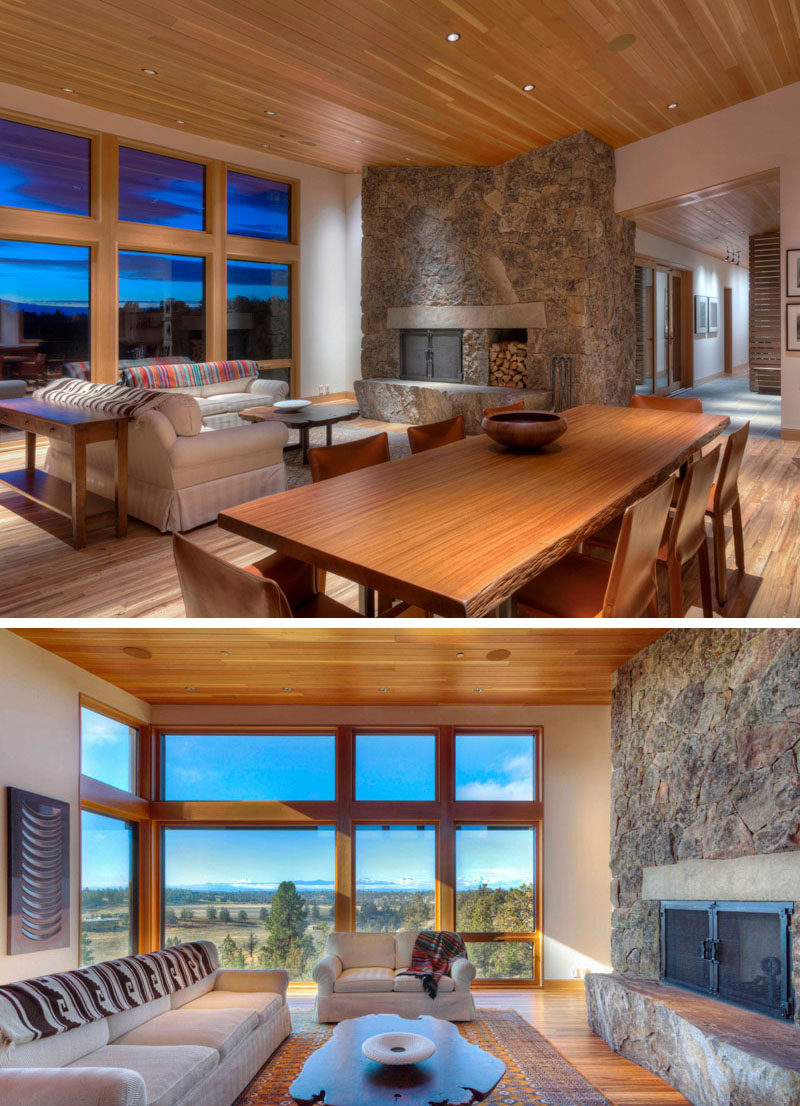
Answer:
[235,1009,610,1106]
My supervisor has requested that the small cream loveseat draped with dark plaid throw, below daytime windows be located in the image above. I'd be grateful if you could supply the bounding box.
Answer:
[313,929,476,1022]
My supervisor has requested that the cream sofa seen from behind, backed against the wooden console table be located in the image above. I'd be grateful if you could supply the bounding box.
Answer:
[35,380,289,532]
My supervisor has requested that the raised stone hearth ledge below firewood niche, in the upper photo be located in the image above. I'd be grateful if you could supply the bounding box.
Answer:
[354,379,552,434]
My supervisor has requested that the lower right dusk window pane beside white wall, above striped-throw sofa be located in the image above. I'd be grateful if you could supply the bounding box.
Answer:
[228,261,292,361]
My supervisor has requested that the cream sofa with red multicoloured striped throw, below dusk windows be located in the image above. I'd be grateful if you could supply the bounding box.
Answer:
[121,361,289,430]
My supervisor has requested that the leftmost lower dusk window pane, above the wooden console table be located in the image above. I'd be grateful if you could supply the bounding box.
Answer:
[0,240,90,386]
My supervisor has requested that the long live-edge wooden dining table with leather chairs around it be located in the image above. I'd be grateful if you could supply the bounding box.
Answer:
[219,405,729,618]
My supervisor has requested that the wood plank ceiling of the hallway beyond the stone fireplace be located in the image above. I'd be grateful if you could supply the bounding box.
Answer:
[621,169,780,269]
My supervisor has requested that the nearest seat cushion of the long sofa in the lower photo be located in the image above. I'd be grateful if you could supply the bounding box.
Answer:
[70,1044,219,1106]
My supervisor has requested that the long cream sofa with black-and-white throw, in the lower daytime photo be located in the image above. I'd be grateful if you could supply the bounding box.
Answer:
[0,941,291,1106]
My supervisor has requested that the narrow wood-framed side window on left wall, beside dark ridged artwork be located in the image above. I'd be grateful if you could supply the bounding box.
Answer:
[80,696,152,964]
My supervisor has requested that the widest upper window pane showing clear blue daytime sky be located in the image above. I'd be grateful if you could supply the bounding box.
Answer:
[162,733,336,801]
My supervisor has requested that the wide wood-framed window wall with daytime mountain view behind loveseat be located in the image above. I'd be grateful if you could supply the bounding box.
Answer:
[150,724,542,987]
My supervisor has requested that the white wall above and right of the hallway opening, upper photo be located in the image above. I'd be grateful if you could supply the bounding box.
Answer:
[614,83,800,438]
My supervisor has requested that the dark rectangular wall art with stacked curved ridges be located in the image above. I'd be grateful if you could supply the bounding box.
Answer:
[6,787,70,956]
